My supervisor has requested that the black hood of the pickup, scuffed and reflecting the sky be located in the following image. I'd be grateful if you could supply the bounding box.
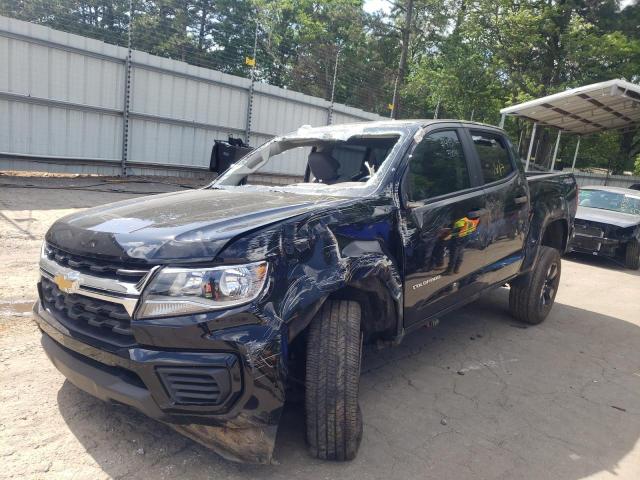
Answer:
[46,188,345,263]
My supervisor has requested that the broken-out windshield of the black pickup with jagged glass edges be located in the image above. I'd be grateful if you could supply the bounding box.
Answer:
[210,126,403,196]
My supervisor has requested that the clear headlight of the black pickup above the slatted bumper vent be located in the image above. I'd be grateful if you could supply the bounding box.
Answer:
[137,262,267,318]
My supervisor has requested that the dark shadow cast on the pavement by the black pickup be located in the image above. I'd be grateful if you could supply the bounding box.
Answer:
[58,290,640,480]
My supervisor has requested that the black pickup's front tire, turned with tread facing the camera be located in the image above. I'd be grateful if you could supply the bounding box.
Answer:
[305,300,362,460]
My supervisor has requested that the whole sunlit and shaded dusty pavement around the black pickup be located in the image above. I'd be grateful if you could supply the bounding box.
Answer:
[0,175,640,480]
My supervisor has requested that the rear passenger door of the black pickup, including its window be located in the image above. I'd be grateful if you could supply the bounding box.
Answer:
[465,126,530,284]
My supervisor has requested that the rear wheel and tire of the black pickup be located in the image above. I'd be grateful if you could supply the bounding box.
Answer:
[509,247,561,325]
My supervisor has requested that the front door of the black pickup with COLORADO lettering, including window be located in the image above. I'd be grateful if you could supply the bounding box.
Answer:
[400,124,487,326]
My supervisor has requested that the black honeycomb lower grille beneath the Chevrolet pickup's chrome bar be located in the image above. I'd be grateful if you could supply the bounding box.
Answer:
[41,277,135,347]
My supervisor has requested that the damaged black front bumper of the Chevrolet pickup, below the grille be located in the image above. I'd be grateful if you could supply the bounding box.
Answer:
[33,302,284,463]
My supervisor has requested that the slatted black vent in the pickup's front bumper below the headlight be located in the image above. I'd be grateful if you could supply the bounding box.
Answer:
[158,367,230,405]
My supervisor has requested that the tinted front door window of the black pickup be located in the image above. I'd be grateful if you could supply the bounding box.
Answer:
[407,130,471,201]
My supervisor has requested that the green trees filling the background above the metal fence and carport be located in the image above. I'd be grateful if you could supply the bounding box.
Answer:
[0,0,640,163]
